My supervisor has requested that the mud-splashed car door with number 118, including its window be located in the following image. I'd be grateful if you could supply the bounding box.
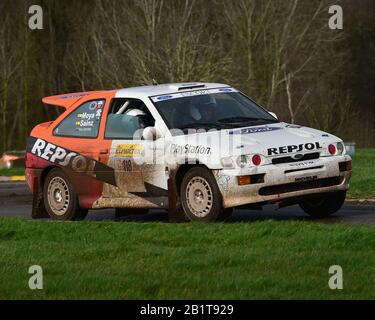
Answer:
[103,98,168,208]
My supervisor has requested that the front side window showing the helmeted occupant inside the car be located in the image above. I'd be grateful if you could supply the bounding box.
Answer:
[105,98,155,140]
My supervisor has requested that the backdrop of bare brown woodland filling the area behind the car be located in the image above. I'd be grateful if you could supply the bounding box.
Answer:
[0,0,375,149]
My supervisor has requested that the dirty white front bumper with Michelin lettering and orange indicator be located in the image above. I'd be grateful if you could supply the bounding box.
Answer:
[214,155,351,208]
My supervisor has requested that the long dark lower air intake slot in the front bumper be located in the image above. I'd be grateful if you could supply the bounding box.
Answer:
[259,177,341,196]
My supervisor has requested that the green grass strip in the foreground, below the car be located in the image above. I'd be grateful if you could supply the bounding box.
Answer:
[0,218,375,299]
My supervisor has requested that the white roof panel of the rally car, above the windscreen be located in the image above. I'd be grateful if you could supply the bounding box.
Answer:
[116,82,230,98]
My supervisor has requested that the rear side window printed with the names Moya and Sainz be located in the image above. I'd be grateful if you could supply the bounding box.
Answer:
[54,99,105,138]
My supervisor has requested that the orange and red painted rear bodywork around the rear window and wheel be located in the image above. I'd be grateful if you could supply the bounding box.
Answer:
[26,90,116,208]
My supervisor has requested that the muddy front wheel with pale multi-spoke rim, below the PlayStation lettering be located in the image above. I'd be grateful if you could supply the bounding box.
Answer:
[180,167,231,222]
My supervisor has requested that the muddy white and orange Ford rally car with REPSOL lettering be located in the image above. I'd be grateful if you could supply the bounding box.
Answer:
[26,83,352,221]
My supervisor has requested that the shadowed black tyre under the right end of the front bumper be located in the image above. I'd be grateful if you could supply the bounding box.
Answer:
[299,191,346,218]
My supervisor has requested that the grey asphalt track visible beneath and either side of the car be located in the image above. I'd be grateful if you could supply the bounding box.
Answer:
[0,182,375,225]
